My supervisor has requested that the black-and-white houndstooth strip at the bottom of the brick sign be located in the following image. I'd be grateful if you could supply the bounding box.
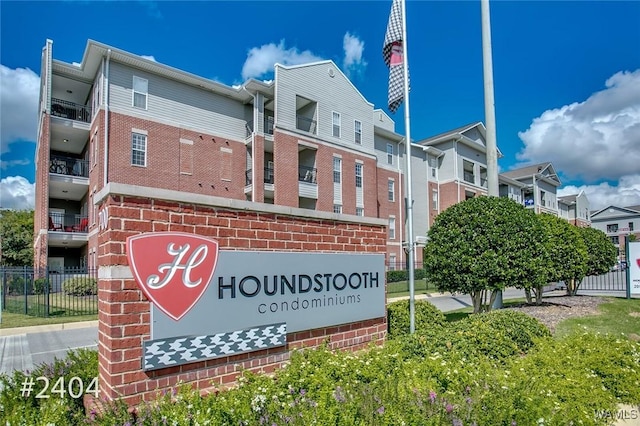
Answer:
[142,323,287,371]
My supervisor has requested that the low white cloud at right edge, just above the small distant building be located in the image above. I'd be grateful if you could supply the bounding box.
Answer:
[558,175,640,210]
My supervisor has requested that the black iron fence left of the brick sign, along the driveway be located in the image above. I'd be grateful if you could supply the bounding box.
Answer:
[0,267,98,317]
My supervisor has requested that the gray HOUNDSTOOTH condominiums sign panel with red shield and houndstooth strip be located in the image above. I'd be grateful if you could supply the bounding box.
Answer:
[127,232,386,369]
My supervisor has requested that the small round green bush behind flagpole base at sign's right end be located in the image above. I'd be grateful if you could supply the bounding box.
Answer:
[387,300,446,339]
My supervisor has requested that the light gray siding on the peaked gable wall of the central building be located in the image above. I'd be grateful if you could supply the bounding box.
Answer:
[275,63,374,154]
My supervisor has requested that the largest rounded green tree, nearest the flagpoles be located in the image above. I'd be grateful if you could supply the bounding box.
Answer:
[424,197,544,313]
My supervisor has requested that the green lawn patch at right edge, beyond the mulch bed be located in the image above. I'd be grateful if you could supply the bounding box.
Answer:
[556,297,640,340]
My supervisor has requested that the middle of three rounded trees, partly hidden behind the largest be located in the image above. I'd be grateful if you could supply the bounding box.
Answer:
[527,213,587,303]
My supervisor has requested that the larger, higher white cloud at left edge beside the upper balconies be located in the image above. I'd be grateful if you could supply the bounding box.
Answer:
[0,65,40,153]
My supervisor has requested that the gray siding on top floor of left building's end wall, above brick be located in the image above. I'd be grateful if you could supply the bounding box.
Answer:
[109,62,252,140]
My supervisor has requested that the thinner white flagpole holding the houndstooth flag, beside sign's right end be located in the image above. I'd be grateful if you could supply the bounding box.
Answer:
[400,0,416,334]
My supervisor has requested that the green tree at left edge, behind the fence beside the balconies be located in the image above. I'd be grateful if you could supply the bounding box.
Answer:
[0,210,33,266]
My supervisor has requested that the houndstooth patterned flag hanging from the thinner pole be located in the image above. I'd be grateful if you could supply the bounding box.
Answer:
[382,0,408,113]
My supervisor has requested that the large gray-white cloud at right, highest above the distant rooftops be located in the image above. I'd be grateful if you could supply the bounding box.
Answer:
[517,69,640,183]
